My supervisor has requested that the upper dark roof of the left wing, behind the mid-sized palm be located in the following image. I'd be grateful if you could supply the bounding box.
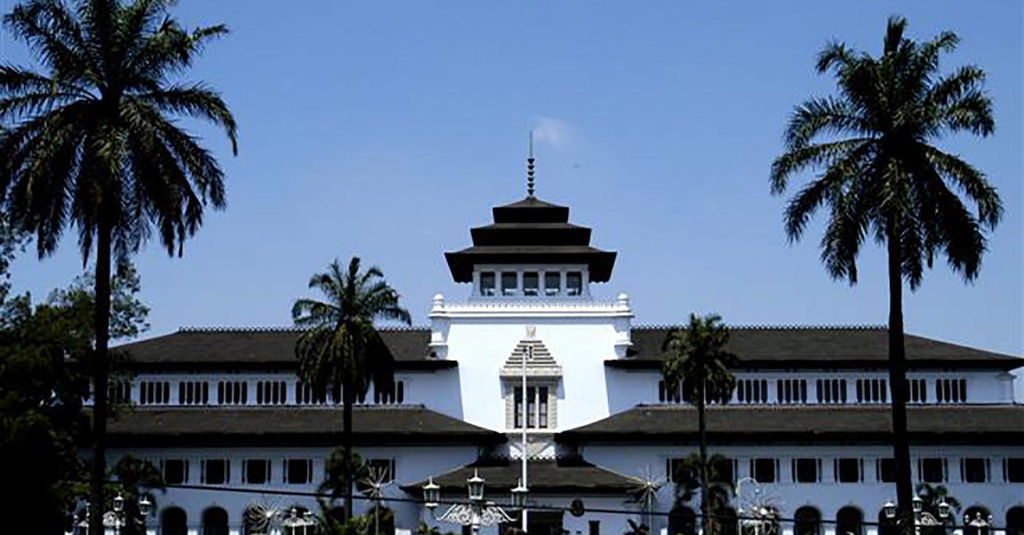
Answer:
[112,329,458,370]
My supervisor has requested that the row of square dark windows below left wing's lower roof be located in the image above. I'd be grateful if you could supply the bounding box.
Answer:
[160,458,395,483]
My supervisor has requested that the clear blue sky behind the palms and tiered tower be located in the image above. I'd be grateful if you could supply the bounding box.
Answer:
[0,0,1024,368]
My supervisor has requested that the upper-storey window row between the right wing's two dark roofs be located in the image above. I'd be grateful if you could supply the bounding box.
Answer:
[657,378,968,405]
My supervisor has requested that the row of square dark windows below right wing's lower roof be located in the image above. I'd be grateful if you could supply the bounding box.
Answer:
[666,457,1024,483]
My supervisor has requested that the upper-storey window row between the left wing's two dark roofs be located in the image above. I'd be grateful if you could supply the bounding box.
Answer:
[108,380,406,405]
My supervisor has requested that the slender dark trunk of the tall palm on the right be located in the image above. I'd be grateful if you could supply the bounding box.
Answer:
[886,223,913,533]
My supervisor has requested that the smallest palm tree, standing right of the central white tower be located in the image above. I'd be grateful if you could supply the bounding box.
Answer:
[662,314,736,533]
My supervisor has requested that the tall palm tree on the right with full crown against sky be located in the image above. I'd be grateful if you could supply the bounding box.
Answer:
[771,16,1002,518]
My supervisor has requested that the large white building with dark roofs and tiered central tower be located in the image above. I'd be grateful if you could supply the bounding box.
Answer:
[110,180,1024,535]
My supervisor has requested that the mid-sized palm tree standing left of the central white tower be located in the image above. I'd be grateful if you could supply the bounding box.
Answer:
[292,256,412,519]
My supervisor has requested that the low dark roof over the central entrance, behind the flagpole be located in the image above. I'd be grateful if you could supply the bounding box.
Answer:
[402,458,640,494]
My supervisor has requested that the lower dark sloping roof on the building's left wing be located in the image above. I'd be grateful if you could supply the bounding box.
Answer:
[108,405,507,446]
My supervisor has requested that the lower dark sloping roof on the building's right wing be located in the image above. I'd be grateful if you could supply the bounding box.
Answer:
[556,405,1024,444]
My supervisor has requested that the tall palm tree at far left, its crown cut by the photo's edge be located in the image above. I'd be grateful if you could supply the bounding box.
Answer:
[0,0,237,533]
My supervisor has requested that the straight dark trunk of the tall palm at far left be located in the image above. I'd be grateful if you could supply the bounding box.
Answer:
[89,218,112,534]
